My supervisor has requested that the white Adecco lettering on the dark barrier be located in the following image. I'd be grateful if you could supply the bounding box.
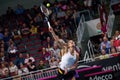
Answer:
[89,74,113,80]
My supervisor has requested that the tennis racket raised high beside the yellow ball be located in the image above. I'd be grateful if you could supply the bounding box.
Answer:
[40,4,51,28]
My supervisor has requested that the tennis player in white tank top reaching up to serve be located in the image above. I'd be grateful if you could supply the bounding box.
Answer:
[49,27,79,80]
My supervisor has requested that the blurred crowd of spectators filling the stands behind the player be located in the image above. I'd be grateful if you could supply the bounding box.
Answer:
[0,0,116,78]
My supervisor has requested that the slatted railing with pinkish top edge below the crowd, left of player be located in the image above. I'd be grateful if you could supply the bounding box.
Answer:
[0,67,57,80]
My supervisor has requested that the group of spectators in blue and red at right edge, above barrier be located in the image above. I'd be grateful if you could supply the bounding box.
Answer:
[98,30,120,59]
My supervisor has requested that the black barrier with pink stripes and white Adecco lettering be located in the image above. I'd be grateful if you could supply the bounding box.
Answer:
[38,56,120,80]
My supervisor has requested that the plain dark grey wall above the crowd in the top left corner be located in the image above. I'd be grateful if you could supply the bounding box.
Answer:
[0,0,43,15]
